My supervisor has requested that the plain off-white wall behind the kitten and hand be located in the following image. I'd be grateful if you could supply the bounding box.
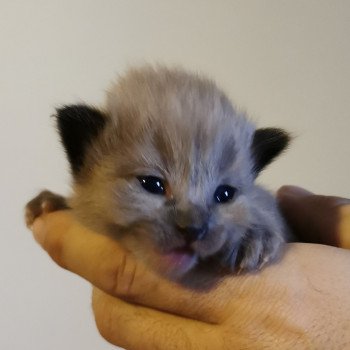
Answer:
[0,0,350,350]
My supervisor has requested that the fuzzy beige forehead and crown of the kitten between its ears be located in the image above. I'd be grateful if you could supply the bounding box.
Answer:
[107,67,254,185]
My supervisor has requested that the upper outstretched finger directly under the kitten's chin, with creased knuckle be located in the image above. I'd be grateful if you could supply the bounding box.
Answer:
[33,211,230,323]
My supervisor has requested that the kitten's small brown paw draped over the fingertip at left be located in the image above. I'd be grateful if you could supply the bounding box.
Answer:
[24,190,69,227]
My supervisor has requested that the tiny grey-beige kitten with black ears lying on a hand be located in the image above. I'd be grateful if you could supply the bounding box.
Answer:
[27,67,289,280]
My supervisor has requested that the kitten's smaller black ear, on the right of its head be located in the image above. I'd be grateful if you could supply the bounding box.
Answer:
[251,128,291,175]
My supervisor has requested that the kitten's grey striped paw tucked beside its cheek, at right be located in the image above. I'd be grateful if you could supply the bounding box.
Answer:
[235,231,285,273]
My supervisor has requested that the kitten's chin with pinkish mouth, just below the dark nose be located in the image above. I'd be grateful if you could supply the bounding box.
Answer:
[156,248,198,279]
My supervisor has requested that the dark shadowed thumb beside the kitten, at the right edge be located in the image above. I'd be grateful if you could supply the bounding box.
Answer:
[277,186,350,246]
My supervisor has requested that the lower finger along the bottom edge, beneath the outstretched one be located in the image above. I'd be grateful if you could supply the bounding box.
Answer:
[92,288,224,350]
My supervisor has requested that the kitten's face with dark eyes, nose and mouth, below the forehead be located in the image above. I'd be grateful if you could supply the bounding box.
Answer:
[83,123,252,276]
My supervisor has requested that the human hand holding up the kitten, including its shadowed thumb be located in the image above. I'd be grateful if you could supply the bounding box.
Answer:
[28,187,350,350]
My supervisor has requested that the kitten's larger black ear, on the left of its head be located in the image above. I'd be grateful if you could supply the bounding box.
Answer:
[56,104,106,175]
